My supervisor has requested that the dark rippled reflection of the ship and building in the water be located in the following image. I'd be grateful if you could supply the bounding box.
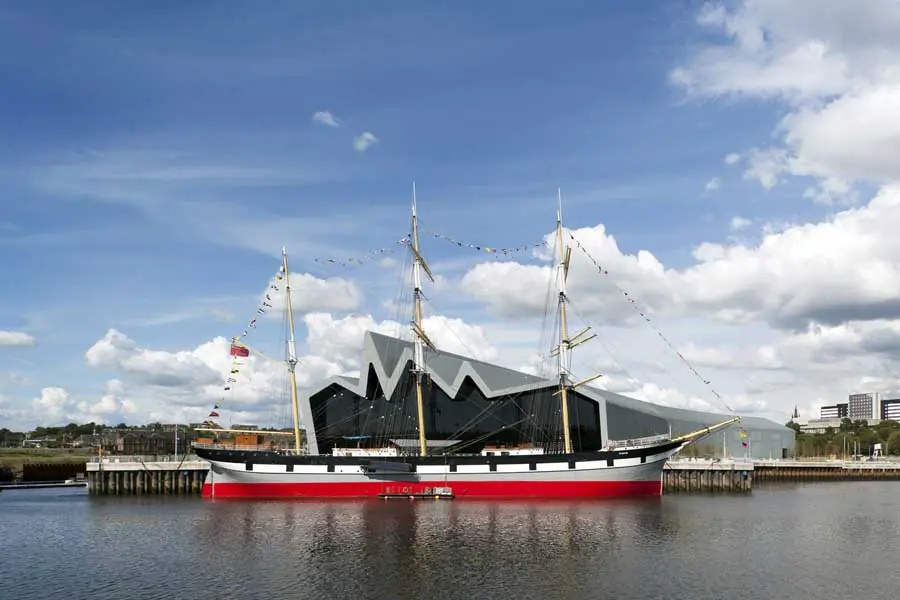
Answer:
[196,498,677,599]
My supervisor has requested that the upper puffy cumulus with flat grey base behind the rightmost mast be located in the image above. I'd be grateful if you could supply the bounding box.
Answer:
[461,187,900,329]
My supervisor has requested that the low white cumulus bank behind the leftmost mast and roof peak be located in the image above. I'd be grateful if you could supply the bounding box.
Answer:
[62,312,497,425]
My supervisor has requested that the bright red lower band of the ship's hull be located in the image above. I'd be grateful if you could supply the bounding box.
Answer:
[203,481,662,499]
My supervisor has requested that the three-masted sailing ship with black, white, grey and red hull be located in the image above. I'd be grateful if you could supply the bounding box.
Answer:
[194,189,738,498]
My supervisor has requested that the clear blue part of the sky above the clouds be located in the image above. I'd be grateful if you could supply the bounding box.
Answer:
[0,1,892,426]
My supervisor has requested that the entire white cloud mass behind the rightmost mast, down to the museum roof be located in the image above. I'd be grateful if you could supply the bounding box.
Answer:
[460,182,900,418]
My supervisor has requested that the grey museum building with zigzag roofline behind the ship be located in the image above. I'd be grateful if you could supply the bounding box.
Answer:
[301,332,794,458]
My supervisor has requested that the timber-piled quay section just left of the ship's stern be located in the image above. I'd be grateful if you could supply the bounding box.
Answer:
[87,455,209,496]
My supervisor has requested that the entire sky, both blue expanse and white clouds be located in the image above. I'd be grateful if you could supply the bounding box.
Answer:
[0,0,900,429]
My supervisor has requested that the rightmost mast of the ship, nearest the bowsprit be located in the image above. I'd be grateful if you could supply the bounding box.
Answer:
[551,189,601,454]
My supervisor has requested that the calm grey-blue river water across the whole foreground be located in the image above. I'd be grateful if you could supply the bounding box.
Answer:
[0,482,900,600]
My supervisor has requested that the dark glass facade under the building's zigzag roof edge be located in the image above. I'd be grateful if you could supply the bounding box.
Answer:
[310,364,602,454]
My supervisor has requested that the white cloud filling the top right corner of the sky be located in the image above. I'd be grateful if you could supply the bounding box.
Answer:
[671,0,900,192]
